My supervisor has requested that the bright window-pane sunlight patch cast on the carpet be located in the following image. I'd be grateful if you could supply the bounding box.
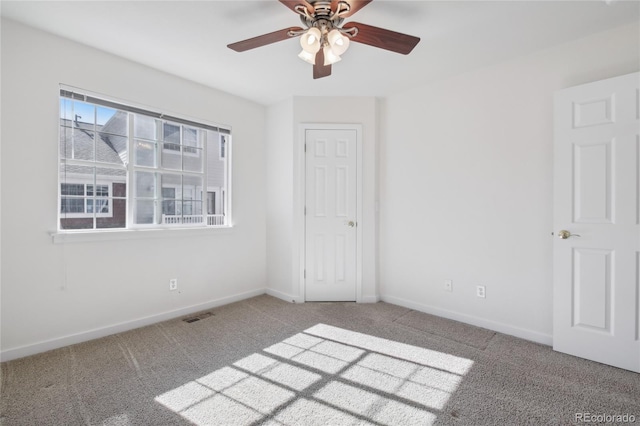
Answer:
[155,324,473,426]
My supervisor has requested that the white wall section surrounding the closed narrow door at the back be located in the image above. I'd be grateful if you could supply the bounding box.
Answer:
[267,97,378,302]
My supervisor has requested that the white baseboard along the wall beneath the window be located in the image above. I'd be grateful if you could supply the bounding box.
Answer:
[0,288,267,362]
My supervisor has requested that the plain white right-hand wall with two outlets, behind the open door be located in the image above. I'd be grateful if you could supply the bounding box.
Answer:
[380,25,640,343]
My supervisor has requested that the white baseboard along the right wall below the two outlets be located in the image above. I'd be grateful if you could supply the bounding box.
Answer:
[382,295,553,346]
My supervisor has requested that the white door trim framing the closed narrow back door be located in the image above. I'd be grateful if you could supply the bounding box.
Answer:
[292,123,363,303]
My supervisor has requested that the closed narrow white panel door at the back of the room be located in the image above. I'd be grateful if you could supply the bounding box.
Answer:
[304,129,357,301]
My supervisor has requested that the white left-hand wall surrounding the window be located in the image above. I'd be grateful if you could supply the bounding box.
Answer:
[1,20,266,359]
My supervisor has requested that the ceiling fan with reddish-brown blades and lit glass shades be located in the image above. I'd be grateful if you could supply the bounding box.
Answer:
[227,0,420,79]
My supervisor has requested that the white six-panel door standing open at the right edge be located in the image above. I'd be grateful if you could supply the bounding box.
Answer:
[553,73,640,372]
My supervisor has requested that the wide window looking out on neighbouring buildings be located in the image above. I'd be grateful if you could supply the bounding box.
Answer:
[58,88,231,230]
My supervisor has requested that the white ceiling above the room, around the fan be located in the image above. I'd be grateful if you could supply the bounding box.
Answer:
[0,0,640,104]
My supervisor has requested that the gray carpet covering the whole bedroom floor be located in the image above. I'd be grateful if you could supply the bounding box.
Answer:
[0,295,640,426]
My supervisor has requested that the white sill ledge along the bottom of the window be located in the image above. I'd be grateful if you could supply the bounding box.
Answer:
[50,226,233,244]
